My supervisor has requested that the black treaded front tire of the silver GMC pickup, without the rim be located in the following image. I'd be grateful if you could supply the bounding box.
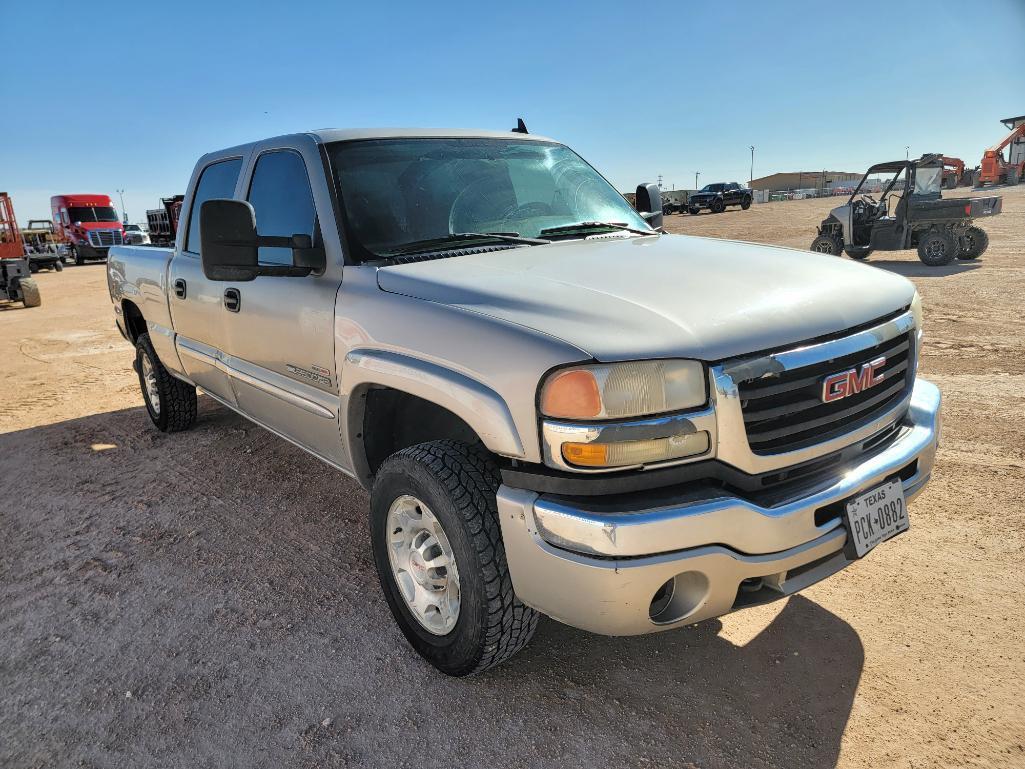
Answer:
[370,440,539,676]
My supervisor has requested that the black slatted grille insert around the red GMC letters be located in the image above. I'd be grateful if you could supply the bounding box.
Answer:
[737,331,914,454]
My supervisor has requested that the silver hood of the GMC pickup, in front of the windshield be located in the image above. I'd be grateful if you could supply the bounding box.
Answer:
[377,235,914,364]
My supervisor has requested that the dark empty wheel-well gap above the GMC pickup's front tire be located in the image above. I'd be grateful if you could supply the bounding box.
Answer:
[361,388,482,475]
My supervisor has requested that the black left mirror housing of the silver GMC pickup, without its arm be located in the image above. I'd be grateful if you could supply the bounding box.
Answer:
[199,199,259,281]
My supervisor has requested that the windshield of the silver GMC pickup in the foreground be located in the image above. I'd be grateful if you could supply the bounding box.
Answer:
[329,138,651,258]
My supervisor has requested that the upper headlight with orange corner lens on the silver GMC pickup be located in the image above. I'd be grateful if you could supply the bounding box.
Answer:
[541,360,708,419]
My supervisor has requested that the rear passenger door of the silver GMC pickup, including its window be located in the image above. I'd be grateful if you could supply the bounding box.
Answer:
[168,157,242,406]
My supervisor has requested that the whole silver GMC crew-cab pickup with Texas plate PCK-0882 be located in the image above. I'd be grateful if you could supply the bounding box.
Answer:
[108,130,940,676]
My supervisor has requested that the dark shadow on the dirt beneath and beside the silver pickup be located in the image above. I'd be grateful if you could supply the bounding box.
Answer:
[0,398,864,769]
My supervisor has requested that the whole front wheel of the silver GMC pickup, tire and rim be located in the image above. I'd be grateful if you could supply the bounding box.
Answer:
[370,441,538,676]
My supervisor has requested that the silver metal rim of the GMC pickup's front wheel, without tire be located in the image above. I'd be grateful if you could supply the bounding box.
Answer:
[386,494,459,636]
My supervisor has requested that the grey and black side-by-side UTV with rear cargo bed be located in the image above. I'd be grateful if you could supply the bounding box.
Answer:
[811,155,1002,267]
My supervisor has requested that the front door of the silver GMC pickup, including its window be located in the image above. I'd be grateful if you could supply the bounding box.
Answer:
[218,136,342,463]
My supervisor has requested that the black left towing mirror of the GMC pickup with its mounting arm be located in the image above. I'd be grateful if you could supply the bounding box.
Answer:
[199,199,326,281]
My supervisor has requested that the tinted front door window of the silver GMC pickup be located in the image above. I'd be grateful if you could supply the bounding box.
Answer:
[249,151,317,265]
